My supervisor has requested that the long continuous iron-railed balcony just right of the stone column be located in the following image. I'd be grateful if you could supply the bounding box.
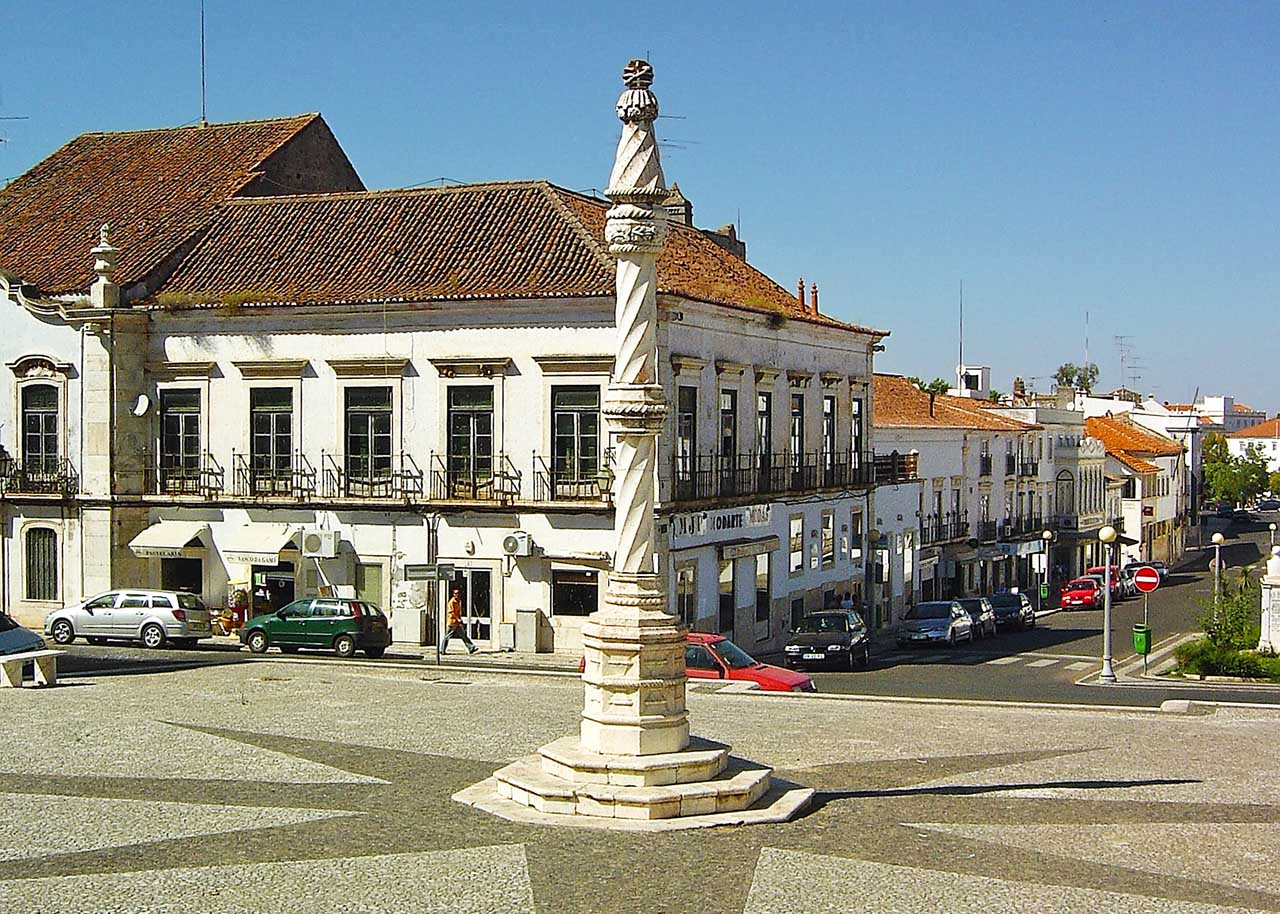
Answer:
[671,451,876,502]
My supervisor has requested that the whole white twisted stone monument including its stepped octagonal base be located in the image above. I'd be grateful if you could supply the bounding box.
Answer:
[454,60,813,828]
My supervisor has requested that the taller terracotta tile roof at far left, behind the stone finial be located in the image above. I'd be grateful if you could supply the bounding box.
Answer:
[0,114,350,294]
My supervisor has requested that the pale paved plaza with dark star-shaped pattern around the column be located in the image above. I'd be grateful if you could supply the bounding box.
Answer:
[0,663,1280,914]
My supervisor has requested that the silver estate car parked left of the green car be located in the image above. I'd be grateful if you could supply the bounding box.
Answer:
[45,589,212,648]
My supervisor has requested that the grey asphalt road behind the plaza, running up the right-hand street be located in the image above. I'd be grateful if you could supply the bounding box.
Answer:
[42,517,1280,707]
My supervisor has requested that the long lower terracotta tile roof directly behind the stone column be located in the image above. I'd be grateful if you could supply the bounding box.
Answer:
[149,180,884,334]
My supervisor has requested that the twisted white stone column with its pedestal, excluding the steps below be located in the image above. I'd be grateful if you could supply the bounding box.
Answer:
[582,60,689,755]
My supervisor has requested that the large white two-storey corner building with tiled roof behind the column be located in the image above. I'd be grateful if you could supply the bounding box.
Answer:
[0,117,901,652]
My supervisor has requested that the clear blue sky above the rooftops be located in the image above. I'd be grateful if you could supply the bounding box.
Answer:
[0,0,1280,413]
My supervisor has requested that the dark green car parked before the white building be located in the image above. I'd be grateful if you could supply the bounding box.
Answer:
[239,597,392,657]
